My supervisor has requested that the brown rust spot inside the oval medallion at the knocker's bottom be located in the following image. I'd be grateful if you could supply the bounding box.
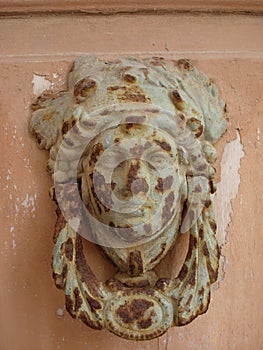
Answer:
[116,299,154,329]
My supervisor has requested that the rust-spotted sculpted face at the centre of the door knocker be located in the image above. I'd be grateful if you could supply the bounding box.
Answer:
[83,123,188,243]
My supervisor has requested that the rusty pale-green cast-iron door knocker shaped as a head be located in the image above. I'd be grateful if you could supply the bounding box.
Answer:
[30,57,229,340]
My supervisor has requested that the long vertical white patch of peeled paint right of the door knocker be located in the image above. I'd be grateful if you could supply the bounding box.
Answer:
[214,133,245,245]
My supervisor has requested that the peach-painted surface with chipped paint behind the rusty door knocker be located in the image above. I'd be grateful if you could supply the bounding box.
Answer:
[0,8,263,350]
